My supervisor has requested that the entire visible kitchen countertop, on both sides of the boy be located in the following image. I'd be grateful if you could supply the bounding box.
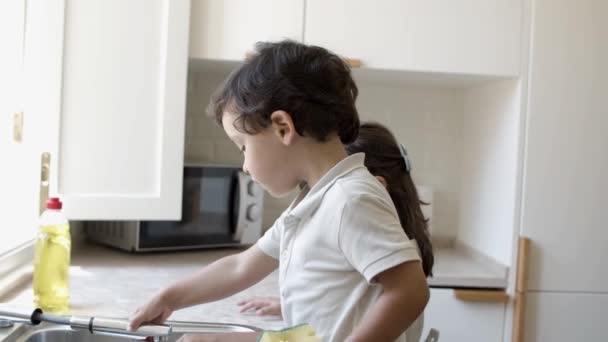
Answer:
[1,240,507,329]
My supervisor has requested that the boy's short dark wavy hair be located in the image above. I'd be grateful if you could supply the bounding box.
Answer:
[207,40,359,144]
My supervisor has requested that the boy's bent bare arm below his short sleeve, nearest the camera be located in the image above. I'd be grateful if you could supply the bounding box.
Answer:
[348,261,430,342]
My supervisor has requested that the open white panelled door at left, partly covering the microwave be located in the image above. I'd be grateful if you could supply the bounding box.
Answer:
[26,0,190,219]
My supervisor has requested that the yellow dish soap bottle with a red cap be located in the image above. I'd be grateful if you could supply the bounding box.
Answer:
[34,197,72,313]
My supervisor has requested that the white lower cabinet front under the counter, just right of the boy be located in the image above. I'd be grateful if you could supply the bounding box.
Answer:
[422,288,505,342]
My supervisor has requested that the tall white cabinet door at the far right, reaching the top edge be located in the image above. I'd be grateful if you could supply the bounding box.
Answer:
[522,0,608,292]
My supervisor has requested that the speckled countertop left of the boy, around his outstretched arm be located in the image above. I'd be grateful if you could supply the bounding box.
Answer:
[1,244,283,329]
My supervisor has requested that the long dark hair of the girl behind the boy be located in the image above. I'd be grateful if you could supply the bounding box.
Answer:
[346,123,434,277]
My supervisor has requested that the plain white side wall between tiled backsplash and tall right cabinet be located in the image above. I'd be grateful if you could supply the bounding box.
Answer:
[458,80,520,265]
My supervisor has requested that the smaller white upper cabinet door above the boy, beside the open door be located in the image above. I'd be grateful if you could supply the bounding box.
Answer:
[190,0,304,61]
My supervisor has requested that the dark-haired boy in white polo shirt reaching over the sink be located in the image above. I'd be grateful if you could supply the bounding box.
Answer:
[131,41,429,342]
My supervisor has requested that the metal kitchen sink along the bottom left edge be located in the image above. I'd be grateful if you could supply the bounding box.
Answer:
[2,321,260,342]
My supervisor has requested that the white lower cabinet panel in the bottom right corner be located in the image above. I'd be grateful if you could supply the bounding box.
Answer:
[524,293,608,342]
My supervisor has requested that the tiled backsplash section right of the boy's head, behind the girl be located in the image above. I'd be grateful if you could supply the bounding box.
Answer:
[357,83,463,239]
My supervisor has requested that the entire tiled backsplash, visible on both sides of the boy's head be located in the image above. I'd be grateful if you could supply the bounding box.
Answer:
[186,72,463,238]
